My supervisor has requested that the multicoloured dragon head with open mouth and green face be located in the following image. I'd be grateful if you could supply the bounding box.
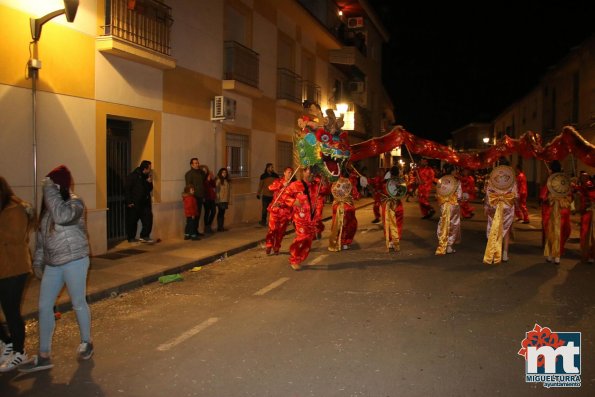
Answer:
[295,104,351,182]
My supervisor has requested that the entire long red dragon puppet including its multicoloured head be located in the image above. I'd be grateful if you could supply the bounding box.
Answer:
[295,105,595,176]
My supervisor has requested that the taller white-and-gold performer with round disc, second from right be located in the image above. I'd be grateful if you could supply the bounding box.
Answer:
[483,165,518,265]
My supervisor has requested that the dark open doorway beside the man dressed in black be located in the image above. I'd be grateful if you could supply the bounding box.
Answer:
[106,118,132,248]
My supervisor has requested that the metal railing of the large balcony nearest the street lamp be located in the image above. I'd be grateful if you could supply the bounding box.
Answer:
[104,0,173,56]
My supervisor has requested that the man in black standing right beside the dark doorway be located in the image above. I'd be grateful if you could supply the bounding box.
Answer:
[125,160,154,243]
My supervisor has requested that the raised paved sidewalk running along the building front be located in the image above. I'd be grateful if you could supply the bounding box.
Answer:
[22,198,373,320]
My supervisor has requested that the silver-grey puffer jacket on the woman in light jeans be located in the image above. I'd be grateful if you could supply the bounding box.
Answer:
[33,185,89,268]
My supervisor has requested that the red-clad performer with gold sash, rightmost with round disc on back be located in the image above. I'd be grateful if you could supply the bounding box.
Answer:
[539,161,572,264]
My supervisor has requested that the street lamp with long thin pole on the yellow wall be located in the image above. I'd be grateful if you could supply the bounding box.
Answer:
[28,0,79,209]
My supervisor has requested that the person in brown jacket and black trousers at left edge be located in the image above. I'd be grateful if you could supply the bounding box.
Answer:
[0,176,35,372]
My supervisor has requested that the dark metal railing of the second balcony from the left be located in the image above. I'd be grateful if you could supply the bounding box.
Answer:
[223,41,259,88]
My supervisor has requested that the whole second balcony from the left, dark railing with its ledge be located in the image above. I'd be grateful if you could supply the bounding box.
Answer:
[223,41,262,98]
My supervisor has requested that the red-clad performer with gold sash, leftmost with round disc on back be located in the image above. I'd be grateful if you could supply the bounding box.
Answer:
[328,178,357,252]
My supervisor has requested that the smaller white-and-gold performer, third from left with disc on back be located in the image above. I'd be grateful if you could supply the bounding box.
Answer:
[436,175,463,255]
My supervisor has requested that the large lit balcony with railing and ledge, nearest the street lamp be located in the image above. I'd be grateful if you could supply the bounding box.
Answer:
[96,0,176,69]
